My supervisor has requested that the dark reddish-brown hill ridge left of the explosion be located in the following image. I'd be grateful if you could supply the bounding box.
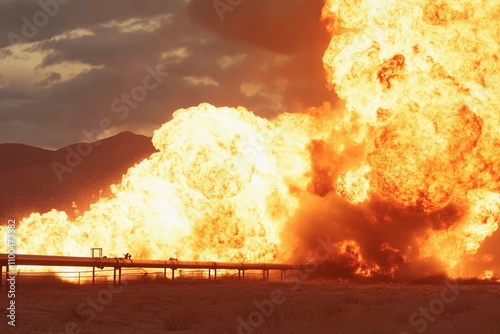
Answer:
[0,132,156,225]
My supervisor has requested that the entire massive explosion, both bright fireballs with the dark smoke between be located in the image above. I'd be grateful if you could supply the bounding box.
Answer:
[0,0,500,277]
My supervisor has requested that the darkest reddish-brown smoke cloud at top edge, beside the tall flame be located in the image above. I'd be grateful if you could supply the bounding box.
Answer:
[189,0,329,53]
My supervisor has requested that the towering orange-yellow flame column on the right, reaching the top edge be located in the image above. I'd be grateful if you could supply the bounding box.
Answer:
[323,0,500,274]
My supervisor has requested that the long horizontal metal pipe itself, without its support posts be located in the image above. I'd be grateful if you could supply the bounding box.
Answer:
[0,254,303,270]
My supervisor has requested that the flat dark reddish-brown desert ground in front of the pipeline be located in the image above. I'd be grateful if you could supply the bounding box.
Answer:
[0,280,500,334]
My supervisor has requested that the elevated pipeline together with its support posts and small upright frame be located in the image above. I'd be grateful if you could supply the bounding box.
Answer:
[0,253,304,289]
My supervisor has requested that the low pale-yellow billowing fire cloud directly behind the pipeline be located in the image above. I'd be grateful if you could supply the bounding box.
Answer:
[1,104,316,261]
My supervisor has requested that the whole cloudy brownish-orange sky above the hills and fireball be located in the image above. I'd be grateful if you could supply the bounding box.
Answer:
[0,0,336,148]
